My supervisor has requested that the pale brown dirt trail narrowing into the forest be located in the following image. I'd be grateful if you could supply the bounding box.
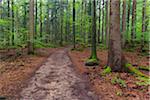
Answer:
[19,49,99,100]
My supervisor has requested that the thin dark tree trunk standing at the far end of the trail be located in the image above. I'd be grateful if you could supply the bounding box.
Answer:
[73,0,76,48]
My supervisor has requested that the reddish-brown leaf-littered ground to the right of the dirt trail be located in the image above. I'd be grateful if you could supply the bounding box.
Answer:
[69,49,150,100]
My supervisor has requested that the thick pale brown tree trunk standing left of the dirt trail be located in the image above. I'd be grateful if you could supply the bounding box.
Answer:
[28,0,34,54]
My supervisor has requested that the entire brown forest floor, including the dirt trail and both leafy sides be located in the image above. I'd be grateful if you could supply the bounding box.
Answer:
[0,48,150,100]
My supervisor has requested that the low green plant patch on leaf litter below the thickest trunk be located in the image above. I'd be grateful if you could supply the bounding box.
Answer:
[111,76,127,88]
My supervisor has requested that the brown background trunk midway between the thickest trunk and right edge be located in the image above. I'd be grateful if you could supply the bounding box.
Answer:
[131,0,136,44]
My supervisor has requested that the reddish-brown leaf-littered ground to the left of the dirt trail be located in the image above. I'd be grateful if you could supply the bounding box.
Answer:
[0,48,56,100]
